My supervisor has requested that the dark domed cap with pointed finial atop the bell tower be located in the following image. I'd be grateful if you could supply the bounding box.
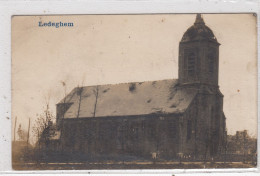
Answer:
[181,14,217,42]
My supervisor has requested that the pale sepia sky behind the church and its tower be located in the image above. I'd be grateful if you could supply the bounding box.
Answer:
[11,14,257,143]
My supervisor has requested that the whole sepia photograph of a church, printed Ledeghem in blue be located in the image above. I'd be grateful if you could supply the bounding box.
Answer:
[11,13,258,170]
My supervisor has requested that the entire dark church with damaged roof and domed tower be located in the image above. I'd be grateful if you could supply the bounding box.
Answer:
[56,14,226,159]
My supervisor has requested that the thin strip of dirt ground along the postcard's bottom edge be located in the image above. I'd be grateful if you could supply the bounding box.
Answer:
[13,162,256,170]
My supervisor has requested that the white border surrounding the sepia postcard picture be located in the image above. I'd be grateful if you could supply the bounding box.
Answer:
[0,0,260,176]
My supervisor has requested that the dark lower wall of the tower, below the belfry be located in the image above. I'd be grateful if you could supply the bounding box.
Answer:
[193,93,225,157]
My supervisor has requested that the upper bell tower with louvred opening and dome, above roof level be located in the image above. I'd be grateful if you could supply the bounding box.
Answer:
[179,14,220,87]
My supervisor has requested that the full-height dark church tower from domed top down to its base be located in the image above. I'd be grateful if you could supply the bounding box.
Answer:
[179,14,226,158]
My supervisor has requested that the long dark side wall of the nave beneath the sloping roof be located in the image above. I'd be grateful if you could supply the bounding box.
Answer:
[61,115,180,159]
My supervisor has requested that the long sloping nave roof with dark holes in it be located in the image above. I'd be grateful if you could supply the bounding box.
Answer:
[60,79,196,118]
